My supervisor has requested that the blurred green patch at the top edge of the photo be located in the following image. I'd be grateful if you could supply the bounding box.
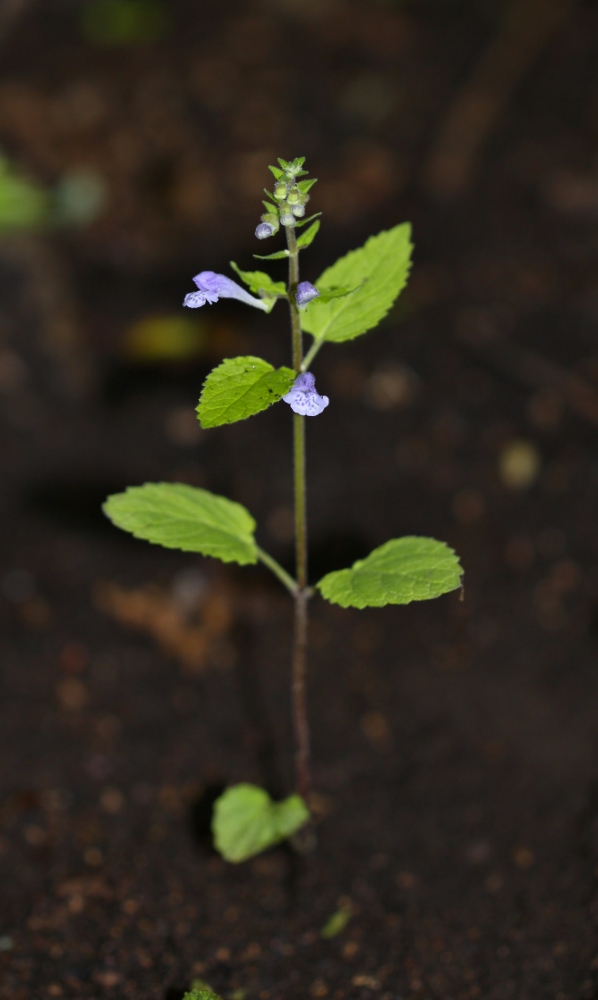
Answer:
[80,0,170,45]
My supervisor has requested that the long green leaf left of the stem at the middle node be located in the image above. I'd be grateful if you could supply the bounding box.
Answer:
[102,483,258,566]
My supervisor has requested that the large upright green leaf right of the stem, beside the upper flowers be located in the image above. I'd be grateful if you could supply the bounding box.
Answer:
[303,223,413,343]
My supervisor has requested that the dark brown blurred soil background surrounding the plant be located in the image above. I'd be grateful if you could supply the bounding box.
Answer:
[0,0,598,1000]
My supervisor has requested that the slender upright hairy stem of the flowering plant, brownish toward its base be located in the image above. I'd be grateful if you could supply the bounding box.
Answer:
[286,226,311,799]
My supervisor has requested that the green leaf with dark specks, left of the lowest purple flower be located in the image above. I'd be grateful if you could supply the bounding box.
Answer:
[197,357,297,427]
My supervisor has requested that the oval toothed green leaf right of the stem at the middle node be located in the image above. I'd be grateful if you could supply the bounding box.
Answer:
[316,536,463,608]
